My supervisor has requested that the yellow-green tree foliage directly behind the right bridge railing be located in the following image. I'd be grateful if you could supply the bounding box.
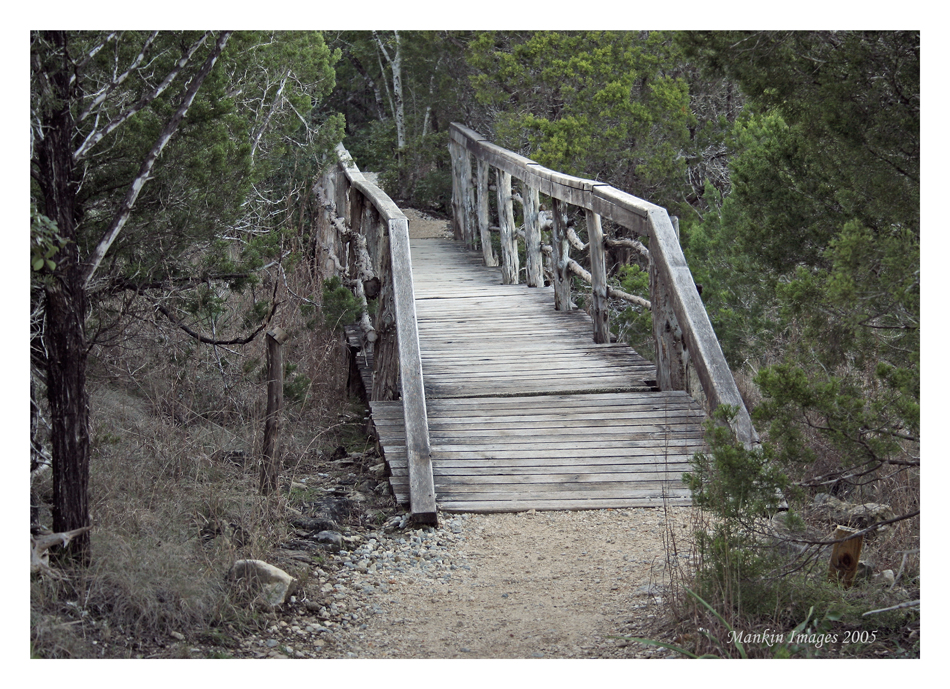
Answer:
[468,31,694,204]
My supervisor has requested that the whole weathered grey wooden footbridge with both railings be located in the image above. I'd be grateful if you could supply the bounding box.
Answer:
[316,124,757,523]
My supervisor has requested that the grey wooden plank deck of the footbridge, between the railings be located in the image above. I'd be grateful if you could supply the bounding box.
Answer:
[371,239,704,512]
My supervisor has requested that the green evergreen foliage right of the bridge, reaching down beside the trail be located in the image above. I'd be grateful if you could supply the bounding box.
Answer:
[679,32,920,644]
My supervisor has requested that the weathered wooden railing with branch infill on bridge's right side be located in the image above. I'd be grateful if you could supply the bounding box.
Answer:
[449,123,758,447]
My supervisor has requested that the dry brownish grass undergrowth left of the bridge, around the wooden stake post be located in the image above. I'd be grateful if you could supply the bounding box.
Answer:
[30,254,394,658]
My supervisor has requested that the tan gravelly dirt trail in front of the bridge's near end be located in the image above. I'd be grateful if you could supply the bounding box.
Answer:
[356,508,690,659]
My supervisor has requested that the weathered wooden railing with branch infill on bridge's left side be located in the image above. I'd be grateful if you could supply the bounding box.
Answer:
[316,144,437,525]
